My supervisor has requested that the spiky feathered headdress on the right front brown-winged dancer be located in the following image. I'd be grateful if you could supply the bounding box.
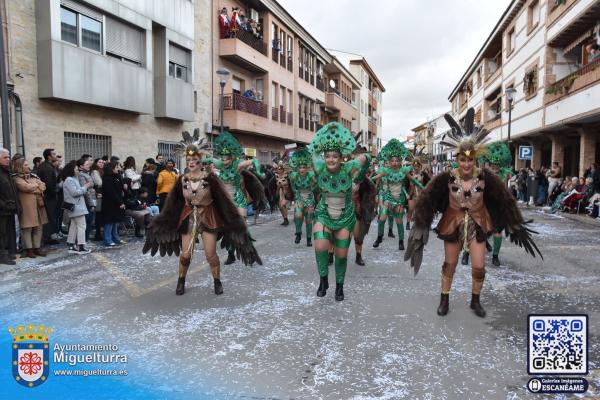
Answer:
[440,108,490,159]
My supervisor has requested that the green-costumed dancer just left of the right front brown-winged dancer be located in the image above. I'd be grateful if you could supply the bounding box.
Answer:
[373,139,423,250]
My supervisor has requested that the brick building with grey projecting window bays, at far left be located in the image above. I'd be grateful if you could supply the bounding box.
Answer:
[0,0,212,165]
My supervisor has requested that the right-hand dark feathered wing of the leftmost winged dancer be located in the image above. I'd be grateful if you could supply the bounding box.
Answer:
[206,174,264,265]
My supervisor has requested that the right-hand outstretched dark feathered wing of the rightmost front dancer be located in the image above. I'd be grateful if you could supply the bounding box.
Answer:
[483,169,544,259]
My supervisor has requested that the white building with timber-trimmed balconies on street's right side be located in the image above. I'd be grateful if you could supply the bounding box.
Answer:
[449,0,600,175]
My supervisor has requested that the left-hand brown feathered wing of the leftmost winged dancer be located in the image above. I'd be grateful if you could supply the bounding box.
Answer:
[142,177,185,257]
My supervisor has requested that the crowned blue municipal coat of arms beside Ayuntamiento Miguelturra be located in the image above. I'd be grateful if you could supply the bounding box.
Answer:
[8,324,52,388]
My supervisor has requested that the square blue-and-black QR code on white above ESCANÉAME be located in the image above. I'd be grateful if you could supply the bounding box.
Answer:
[527,314,588,375]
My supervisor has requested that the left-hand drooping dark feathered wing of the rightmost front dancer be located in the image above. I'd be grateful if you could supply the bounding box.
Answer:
[404,172,450,275]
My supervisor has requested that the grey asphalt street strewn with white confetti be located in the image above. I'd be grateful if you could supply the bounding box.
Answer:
[0,211,600,399]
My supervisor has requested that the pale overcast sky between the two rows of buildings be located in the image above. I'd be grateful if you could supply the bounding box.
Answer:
[278,0,510,140]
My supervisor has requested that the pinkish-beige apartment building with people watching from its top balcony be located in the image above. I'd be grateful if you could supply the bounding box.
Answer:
[212,0,332,163]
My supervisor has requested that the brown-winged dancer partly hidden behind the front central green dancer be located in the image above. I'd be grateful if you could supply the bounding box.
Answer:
[352,146,377,266]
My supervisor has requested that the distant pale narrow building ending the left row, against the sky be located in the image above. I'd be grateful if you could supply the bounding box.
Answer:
[329,49,385,153]
